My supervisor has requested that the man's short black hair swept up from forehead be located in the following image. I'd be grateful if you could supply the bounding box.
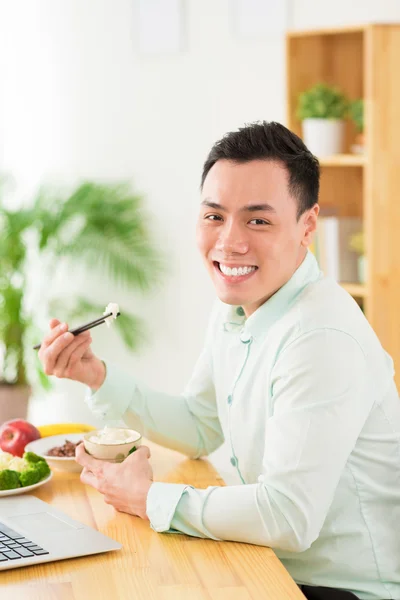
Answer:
[200,121,320,219]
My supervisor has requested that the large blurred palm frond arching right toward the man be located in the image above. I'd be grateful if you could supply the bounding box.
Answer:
[35,183,165,290]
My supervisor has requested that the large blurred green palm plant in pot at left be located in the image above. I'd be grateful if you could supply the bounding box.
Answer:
[0,182,162,424]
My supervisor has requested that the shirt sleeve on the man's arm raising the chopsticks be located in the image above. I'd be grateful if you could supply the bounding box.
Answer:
[85,302,224,458]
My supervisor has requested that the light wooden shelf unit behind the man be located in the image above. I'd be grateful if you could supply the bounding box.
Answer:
[286,23,400,389]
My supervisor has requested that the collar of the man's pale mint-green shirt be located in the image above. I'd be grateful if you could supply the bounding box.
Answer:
[223,250,322,342]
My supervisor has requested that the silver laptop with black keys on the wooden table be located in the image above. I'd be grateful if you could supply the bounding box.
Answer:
[0,494,122,571]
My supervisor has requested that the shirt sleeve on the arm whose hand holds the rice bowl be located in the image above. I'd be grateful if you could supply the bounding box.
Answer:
[148,329,373,552]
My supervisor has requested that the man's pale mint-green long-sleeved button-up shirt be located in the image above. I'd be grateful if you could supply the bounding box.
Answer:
[87,252,400,600]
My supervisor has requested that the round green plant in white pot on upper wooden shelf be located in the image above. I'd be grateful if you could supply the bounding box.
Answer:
[297,83,348,156]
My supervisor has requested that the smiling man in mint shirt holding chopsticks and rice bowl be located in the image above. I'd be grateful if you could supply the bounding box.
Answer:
[40,122,400,600]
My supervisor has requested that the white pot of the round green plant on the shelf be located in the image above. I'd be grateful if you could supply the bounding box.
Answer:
[303,119,345,157]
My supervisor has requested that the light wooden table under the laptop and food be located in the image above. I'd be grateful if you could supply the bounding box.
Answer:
[0,444,304,600]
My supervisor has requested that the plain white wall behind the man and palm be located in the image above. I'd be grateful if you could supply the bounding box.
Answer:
[0,0,400,478]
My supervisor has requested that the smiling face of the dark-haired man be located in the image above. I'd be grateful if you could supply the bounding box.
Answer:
[197,160,319,316]
